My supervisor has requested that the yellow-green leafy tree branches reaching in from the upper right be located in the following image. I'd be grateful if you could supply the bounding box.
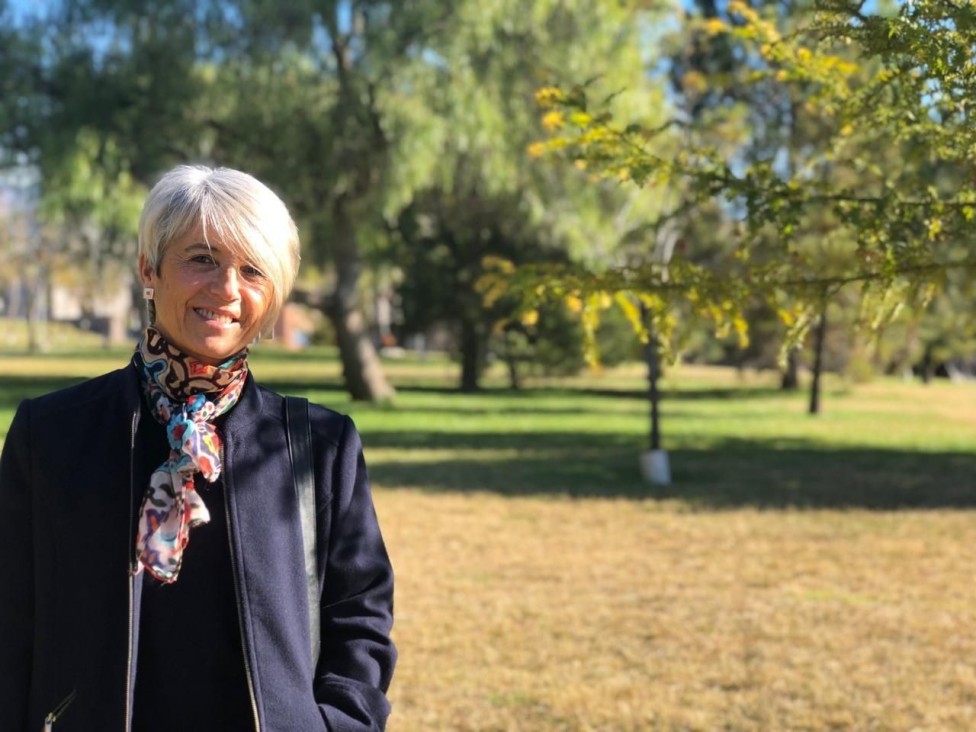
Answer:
[515,0,976,409]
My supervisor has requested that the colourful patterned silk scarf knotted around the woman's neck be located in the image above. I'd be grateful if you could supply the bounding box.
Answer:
[133,326,247,584]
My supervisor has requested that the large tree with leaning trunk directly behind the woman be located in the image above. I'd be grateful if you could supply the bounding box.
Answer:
[4,0,445,399]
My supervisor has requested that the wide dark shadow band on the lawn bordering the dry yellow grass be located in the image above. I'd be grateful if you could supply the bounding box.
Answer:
[365,432,976,510]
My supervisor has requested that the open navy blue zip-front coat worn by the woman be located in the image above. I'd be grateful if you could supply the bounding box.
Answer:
[0,366,396,732]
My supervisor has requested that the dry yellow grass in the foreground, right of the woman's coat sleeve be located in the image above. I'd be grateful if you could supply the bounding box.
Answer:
[376,486,976,732]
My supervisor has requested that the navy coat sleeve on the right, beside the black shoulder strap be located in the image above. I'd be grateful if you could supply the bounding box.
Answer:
[315,417,396,732]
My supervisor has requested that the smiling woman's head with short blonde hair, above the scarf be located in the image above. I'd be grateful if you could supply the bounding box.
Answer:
[139,166,299,364]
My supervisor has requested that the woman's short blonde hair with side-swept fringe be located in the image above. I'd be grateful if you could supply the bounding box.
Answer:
[139,165,300,332]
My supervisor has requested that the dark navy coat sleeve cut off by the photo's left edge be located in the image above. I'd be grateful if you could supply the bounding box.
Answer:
[0,401,34,730]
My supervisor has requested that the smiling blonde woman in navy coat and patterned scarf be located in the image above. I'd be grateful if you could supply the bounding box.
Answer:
[0,166,396,732]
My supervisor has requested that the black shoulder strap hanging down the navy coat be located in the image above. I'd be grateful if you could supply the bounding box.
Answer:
[285,397,321,673]
